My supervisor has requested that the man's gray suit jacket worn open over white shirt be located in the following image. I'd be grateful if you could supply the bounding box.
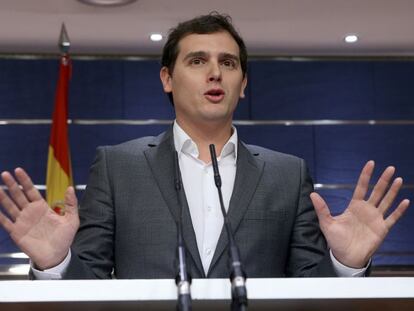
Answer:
[64,130,335,279]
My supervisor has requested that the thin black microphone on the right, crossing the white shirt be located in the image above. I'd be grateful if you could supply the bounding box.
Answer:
[209,144,248,311]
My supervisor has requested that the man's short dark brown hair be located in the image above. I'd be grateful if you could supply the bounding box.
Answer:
[161,12,247,103]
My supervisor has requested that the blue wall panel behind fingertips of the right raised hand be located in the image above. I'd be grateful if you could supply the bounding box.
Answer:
[315,125,414,184]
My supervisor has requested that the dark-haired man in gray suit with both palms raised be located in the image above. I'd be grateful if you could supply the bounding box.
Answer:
[0,14,409,278]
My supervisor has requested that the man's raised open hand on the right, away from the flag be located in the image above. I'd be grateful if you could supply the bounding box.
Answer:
[311,161,410,268]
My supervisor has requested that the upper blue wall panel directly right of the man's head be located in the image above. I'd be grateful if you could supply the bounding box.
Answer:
[250,61,374,120]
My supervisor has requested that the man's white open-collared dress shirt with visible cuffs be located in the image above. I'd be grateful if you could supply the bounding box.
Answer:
[31,121,368,280]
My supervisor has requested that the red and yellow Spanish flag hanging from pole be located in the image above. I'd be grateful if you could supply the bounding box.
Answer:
[46,54,73,214]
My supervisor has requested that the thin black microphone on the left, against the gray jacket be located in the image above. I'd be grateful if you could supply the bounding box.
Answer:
[174,151,192,311]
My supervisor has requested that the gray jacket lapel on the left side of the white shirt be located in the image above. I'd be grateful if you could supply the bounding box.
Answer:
[144,129,204,277]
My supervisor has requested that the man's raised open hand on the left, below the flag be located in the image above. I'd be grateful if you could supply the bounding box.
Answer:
[0,168,79,270]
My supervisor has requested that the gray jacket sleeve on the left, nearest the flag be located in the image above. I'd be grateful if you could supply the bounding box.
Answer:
[63,147,115,279]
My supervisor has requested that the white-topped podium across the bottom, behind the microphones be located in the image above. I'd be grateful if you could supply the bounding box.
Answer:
[0,278,414,311]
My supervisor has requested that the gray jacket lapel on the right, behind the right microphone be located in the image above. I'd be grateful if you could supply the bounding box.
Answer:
[207,141,264,277]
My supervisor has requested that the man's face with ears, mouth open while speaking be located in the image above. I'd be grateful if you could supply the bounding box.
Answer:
[160,31,247,123]
